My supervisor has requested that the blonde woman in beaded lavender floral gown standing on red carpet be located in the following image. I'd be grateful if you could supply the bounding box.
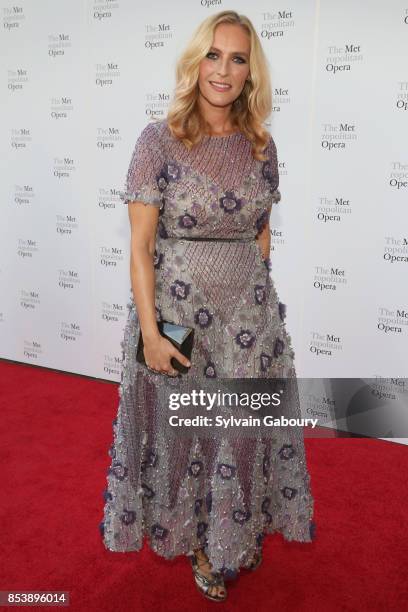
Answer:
[101,11,313,601]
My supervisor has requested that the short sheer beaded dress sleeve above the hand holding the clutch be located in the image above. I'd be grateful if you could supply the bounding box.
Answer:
[120,123,165,207]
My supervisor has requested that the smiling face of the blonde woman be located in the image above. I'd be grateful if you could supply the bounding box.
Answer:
[198,23,250,106]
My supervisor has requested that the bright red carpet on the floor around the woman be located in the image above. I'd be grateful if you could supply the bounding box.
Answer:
[0,360,408,612]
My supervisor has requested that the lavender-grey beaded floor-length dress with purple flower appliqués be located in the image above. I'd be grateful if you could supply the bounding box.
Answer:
[100,119,315,572]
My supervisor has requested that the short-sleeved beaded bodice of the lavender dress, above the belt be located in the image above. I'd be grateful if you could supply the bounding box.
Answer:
[122,119,280,239]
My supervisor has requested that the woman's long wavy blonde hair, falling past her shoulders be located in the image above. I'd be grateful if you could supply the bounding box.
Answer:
[167,11,272,161]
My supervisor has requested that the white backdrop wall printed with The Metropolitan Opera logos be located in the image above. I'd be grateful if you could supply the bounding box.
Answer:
[0,0,408,410]
